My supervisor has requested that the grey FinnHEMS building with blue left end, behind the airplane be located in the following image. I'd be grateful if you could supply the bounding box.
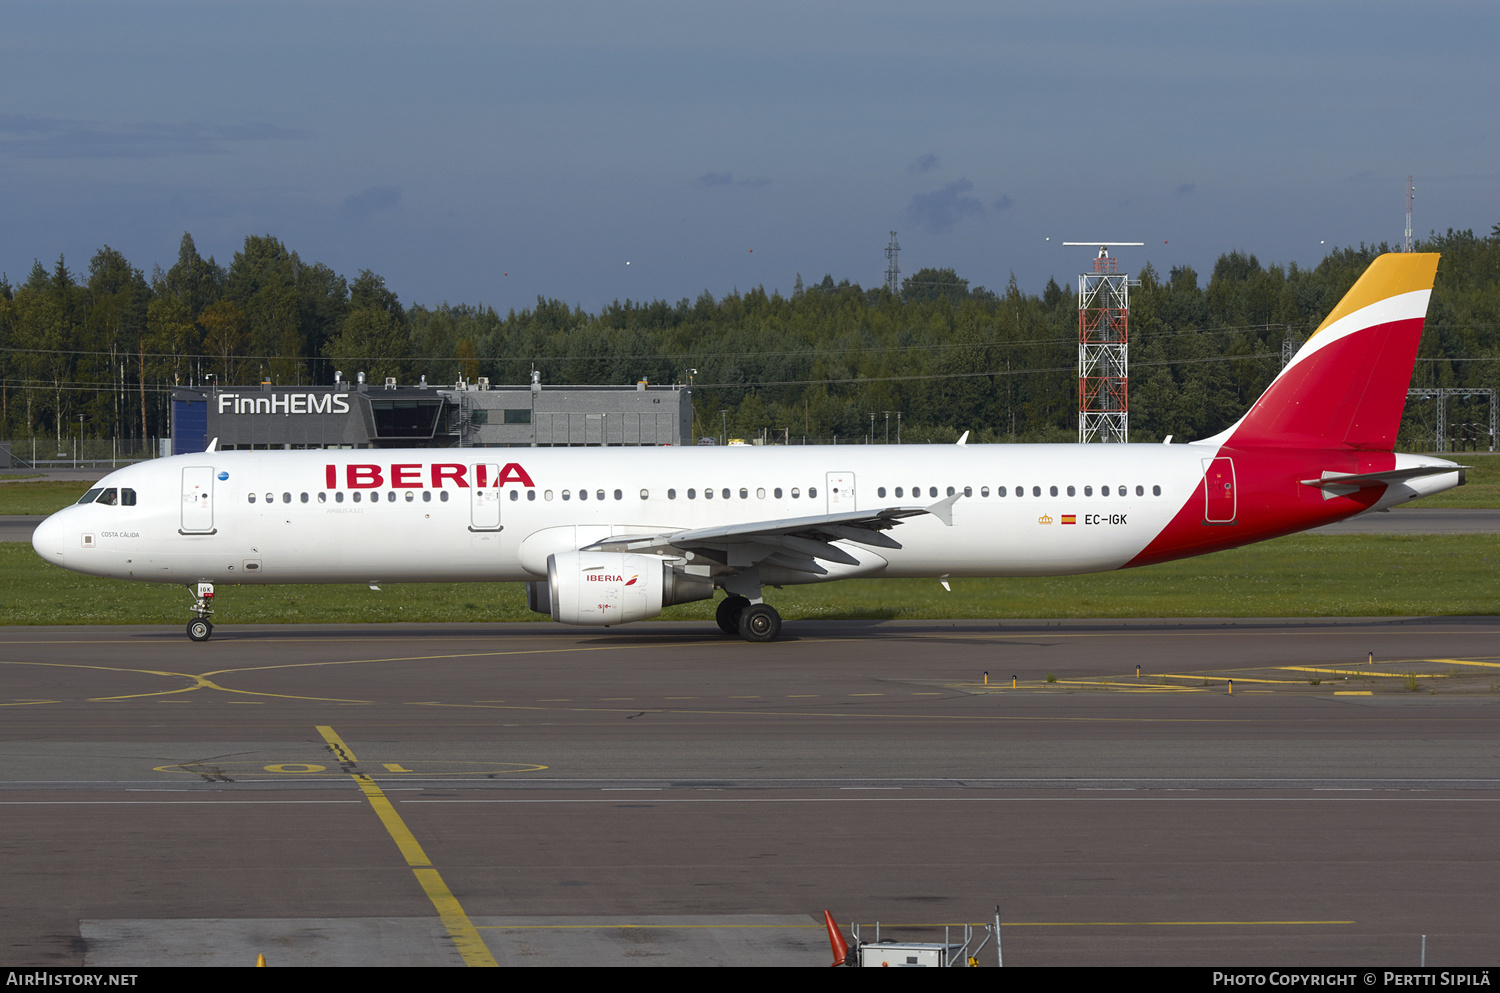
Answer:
[171,378,693,455]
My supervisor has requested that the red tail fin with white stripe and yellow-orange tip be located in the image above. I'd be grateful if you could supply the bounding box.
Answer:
[1220,255,1439,452]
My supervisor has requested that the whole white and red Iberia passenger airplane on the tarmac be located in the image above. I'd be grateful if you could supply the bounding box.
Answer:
[32,254,1464,642]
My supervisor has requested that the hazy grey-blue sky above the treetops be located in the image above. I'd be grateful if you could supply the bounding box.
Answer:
[0,0,1500,311]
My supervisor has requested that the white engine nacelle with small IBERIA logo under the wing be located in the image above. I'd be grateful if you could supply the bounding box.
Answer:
[546,552,714,626]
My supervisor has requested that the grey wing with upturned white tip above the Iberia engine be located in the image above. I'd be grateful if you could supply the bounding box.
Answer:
[581,494,962,576]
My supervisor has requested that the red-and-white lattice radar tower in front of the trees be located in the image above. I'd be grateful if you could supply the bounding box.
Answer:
[1064,242,1145,444]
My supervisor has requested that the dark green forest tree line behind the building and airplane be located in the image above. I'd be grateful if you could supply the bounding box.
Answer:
[0,225,1500,449]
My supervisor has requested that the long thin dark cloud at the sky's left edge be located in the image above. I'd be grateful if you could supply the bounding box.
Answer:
[0,114,308,159]
